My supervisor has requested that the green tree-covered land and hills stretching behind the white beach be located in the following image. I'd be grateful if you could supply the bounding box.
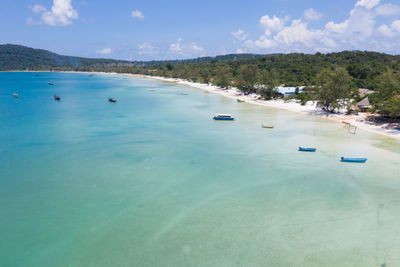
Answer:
[0,45,400,118]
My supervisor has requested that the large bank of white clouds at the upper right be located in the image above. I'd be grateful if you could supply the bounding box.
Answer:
[232,0,400,53]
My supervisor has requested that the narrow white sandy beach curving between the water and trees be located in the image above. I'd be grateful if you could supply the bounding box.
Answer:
[7,71,400,140]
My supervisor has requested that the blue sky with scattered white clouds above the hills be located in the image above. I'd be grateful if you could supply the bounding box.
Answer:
[0,0,400,60]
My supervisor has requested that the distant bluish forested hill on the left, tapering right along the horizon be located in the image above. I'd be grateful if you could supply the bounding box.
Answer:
[0,44,261,71]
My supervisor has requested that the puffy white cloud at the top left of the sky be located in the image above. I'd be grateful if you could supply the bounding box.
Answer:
[27,0,78,26]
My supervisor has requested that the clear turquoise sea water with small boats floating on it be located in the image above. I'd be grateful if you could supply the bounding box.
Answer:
[0,73,400,267]
